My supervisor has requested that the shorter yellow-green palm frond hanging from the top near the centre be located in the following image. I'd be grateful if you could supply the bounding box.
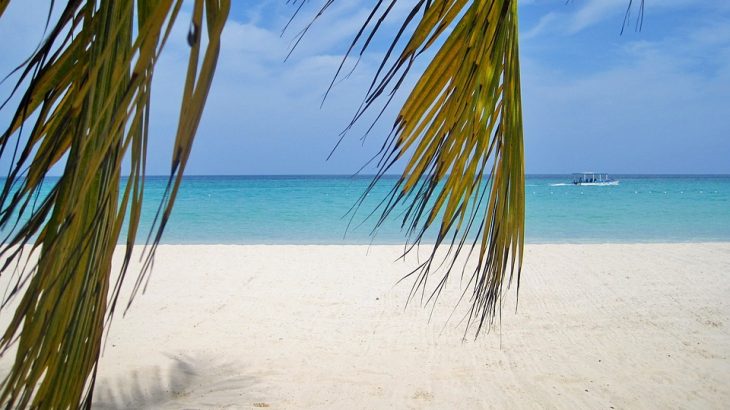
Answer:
[302,0,525,334]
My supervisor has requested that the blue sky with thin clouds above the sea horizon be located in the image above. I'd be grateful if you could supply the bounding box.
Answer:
[0,0,730,174]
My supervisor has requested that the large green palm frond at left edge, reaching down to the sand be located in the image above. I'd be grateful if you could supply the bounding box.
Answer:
[0,0,230,408]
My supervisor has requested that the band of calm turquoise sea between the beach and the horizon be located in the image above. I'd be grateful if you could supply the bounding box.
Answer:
[1,175,730,244]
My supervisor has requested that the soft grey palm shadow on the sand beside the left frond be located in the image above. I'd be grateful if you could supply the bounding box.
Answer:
[93,355,258,410]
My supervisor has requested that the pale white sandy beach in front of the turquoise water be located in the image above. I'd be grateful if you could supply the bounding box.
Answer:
[0,243,730,409]
